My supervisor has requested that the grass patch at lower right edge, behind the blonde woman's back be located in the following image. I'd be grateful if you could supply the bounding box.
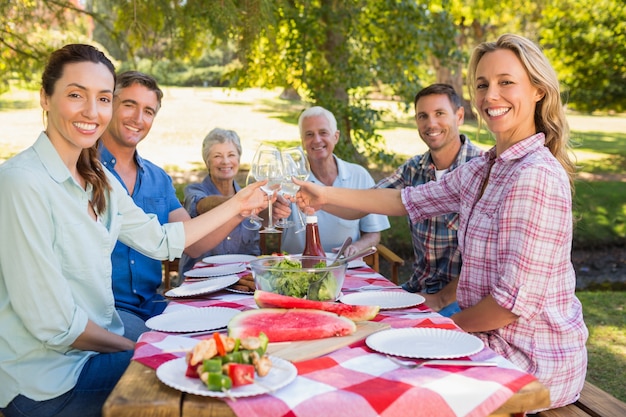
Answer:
[576,291,626,401]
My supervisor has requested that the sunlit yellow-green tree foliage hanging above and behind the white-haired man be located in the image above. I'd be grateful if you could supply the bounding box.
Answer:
[212,0,454,162]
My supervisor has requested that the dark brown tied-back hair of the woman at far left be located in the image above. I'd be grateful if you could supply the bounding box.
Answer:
[41,44,115,213]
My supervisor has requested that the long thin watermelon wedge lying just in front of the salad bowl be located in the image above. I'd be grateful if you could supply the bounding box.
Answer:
[254,290,380,321]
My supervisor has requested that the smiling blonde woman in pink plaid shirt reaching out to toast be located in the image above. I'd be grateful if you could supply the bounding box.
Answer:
[297,34,588,407]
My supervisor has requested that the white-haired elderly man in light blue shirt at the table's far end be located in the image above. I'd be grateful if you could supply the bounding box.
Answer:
[281,106,389,255]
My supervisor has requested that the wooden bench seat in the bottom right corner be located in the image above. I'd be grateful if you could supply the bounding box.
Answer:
[537,381,626,417]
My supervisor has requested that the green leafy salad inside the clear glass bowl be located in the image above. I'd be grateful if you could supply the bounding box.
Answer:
[257,258,337,301]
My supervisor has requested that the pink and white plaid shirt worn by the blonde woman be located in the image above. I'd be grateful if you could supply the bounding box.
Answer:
[402,133,588,407]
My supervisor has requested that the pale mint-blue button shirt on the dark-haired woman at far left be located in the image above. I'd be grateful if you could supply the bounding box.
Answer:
[0,133,185,407]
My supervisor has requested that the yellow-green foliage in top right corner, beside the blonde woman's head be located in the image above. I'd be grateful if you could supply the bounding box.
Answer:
[541,0,626,112]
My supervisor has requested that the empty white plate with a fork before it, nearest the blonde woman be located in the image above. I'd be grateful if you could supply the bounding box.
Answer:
[365,327,485,359]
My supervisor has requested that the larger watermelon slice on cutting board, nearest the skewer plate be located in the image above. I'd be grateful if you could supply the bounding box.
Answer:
[228,308,356,342]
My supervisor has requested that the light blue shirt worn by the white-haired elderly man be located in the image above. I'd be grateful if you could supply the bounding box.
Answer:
[281,155,390,253]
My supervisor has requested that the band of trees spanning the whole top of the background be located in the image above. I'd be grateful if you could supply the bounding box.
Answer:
[0,0,626,158]
